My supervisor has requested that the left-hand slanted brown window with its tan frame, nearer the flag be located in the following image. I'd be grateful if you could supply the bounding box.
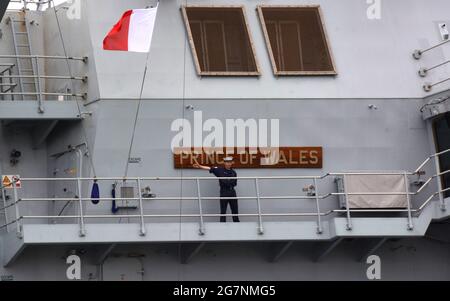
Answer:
[182,6,260,76]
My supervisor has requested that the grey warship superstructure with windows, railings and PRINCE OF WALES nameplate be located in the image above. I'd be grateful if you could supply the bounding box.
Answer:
[0,0,450,281]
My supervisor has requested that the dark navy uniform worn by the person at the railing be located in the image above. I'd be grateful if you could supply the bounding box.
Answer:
[209,167,239,223]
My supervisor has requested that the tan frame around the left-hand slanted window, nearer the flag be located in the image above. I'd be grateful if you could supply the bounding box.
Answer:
[181,5,261,77]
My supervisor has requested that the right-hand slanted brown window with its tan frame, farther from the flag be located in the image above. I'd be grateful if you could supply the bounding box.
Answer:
[258,5,336,75]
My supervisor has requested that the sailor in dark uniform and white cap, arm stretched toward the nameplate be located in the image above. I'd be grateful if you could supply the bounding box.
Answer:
[193,157,239,223]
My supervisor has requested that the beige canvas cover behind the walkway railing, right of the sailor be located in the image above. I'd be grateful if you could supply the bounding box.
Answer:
[344,175,407,208]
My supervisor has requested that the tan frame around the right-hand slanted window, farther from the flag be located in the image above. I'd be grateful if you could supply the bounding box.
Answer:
[256,4,338,76]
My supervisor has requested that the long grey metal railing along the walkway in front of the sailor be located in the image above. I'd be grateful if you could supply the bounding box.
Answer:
[0,149,450,237]
